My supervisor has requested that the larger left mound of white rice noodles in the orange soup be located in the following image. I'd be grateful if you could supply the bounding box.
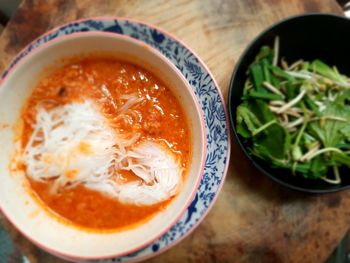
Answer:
[23,101,118,194]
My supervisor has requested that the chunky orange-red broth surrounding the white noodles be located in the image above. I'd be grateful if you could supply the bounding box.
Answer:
[22,56,191,230]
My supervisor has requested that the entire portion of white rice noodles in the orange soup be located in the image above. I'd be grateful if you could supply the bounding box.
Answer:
[22,100,183,205]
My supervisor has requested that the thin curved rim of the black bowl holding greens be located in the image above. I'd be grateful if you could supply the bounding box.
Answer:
[228,12,350,194]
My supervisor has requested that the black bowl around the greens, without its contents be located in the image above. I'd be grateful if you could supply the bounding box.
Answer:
[228,14,350,193]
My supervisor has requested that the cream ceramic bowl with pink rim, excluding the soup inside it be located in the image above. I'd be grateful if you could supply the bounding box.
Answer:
[0,32,206,260]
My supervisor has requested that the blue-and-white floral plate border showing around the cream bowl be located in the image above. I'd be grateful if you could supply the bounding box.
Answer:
[2,18,230,262]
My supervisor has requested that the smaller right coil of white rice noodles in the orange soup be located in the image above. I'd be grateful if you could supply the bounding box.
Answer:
[87,141,182,205]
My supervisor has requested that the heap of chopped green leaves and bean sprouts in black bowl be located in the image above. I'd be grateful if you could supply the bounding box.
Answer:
[237,37,350,184]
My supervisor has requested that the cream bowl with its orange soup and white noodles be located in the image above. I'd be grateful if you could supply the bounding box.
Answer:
[0,32,206,260]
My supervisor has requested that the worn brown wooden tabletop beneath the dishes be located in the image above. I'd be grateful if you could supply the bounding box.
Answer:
[0,0,350,262]
